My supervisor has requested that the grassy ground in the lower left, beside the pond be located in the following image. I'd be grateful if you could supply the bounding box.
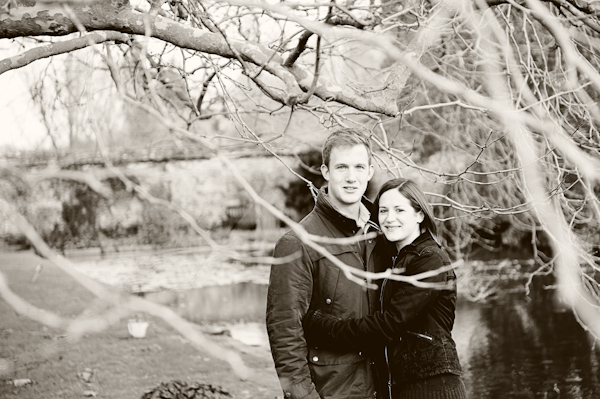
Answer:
[0,252,281,399]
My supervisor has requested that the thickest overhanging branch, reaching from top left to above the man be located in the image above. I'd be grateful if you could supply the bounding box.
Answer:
[0,3,404,116]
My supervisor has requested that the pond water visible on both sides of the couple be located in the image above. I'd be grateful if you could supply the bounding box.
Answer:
[144,283,600,399]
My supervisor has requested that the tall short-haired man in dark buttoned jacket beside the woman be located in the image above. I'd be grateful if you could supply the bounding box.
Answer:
[267,129,377,399]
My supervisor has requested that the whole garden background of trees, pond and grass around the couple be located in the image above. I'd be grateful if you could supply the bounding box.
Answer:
[0,0,600,398]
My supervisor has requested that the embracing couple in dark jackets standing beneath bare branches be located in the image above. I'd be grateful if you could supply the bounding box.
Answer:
[267,129,466,399]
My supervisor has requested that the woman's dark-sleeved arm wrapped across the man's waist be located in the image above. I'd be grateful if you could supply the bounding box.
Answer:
[303,252,448,349]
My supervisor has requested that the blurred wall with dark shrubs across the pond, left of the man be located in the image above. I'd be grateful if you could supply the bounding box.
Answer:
[0,158,293,251]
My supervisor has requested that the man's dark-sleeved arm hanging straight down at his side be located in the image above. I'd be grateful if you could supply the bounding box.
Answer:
[267,234,320,399]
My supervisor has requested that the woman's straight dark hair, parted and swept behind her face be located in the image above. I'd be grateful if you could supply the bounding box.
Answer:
[375,177,440,244]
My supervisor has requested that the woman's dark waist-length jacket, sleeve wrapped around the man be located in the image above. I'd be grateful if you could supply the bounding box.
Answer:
[305,233,462,398]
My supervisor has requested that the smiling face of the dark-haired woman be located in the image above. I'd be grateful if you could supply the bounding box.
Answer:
[379,189,425,249]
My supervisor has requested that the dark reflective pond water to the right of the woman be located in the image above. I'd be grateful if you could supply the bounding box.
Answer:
[464,292,600,399]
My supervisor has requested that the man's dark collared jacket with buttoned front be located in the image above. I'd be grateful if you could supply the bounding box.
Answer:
[267,188,378,399]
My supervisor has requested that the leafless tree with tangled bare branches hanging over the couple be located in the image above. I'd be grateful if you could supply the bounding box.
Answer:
[0,0,600,378]
